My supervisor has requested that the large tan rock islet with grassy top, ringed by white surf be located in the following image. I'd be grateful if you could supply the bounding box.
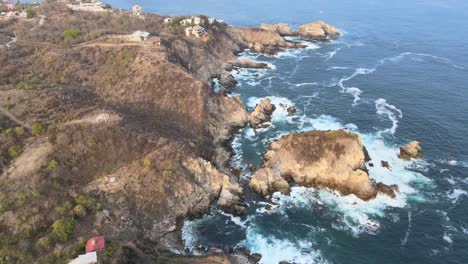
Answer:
[250,130,397,200]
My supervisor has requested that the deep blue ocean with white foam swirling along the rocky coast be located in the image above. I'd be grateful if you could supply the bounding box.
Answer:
[110,0,468,263]
